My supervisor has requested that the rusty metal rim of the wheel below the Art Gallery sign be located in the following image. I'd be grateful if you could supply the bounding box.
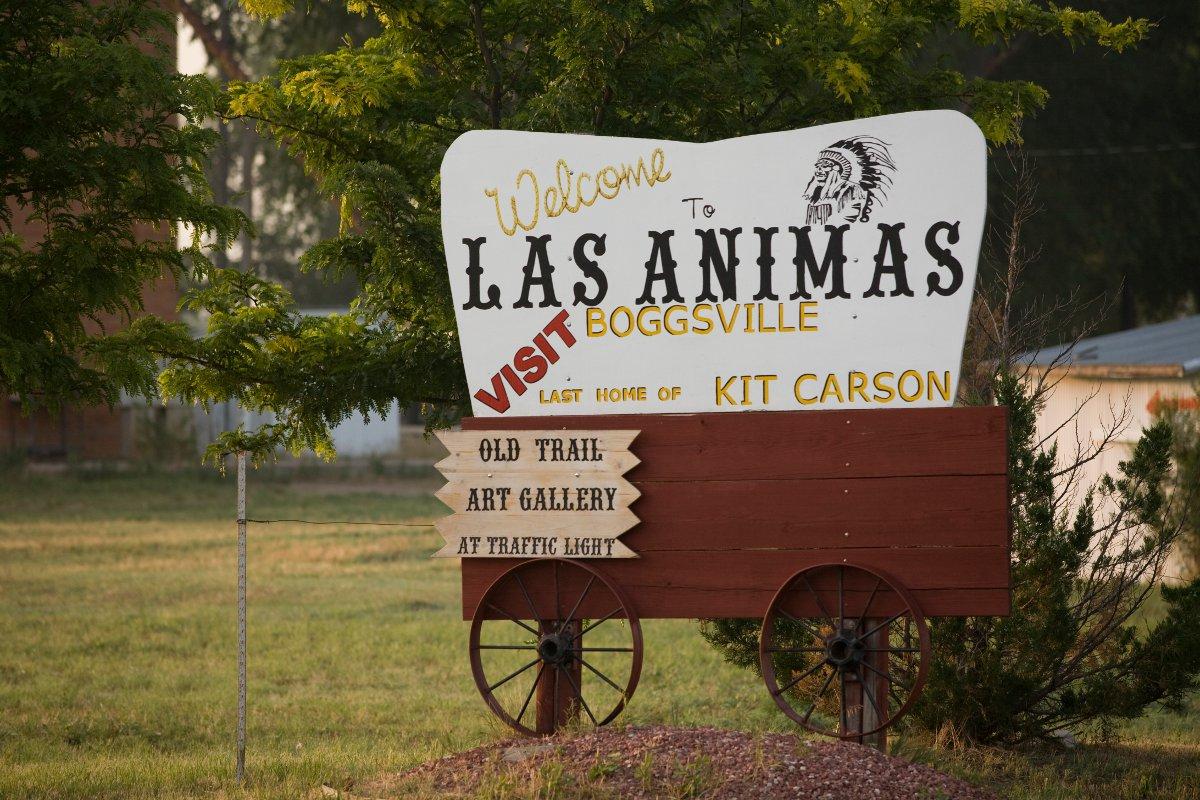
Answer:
[469,558,642,736]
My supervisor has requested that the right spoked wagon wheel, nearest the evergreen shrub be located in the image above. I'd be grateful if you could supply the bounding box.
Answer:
[758,564,930,739]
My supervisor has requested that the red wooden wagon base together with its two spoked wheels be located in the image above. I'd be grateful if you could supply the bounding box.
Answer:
[453,408,1010,744]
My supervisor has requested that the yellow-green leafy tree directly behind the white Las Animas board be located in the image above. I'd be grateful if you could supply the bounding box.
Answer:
[154,0,1148,456]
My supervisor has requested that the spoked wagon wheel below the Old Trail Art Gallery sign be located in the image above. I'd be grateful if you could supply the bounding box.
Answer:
[470,559,642,736]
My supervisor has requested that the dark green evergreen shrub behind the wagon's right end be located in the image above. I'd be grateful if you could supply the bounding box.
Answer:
[702,375,1200,744]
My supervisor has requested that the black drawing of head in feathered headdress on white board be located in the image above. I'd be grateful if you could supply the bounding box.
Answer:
[804,136,896,225]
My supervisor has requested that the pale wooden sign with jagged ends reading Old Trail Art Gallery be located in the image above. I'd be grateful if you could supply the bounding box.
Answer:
[434,431,640,559]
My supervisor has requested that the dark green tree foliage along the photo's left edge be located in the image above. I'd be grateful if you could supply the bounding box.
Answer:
[0,0,246,409]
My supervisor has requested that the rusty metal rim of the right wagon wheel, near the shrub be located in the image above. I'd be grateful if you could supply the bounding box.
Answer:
[758,561,930,739]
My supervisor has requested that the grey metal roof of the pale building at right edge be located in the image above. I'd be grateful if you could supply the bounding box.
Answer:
[1019,314,1200,378]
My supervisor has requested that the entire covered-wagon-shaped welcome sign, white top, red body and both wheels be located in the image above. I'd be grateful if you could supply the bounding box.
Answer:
[437,112,1012,745]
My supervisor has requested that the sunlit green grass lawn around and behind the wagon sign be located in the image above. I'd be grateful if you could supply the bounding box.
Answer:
[0,473,1200,800]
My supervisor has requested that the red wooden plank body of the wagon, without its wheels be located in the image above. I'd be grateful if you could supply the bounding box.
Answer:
[462,407,1009,619]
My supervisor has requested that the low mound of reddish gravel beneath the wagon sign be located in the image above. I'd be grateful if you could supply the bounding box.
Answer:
[354,727,995,800]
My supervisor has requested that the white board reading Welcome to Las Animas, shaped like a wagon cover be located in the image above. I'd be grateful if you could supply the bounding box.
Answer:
[442,112,985,416]
